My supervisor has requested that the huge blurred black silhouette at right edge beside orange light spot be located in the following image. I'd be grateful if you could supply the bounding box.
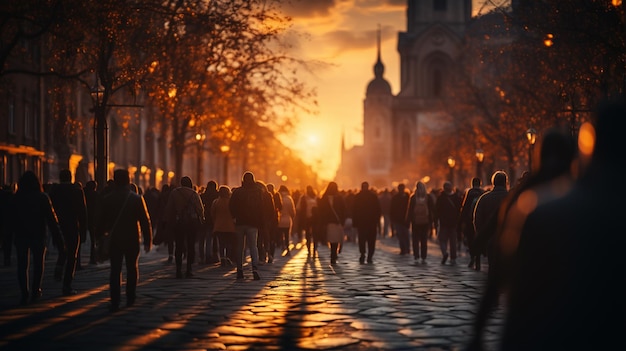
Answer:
[502,101,626,350]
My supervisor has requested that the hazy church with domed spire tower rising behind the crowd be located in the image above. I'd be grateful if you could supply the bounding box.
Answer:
[336,0,472,189]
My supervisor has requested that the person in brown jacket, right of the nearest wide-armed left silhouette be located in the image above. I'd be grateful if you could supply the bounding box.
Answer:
[166,176,204,279]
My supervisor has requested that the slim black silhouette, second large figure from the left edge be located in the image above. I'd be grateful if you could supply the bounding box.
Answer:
[50,169,87,295]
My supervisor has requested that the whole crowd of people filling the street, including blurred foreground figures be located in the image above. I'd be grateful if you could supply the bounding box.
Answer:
[1,99,626,350]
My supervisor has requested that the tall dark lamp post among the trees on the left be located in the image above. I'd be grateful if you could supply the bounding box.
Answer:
[91,81,109,189]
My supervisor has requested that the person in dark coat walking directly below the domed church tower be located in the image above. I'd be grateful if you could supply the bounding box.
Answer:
[352,182,382,264]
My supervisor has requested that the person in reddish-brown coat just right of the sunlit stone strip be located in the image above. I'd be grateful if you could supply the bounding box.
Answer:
[312,182,347,264]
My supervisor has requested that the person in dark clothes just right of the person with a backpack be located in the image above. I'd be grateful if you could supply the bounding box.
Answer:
[435,181,461,264]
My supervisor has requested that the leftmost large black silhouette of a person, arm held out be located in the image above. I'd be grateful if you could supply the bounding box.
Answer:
[8,171,65,305]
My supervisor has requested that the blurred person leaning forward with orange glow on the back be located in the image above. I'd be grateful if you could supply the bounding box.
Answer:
[464,129,576,350]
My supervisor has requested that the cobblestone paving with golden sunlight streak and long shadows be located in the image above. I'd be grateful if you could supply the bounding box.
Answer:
[0,238,502,350]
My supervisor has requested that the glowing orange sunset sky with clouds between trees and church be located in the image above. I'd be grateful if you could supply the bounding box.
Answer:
[282,0,498,180]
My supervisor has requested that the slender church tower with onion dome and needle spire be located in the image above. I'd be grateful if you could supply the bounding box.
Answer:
[363,27,393,190]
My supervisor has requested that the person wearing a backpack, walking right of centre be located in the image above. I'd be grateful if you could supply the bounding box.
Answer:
[408,181,435,264]
